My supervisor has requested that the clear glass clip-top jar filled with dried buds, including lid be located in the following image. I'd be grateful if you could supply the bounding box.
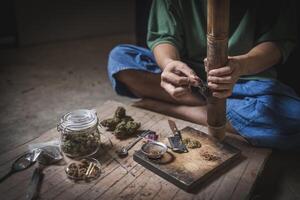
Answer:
[57,109,101,158]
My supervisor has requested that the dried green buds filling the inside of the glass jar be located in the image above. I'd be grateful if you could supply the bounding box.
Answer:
[61,132,100,157]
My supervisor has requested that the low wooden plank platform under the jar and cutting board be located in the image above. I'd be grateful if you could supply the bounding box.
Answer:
[0,101,271,199]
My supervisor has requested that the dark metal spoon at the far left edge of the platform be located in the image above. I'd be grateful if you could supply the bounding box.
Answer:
[0,152,35,183]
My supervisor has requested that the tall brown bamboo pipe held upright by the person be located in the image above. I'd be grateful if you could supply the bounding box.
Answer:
[207,0,230,140]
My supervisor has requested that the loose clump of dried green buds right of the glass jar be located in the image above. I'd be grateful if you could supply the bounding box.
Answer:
[100,106,141,139]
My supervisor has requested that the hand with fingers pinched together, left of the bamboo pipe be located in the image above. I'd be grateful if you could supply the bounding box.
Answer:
[161,60,200,99]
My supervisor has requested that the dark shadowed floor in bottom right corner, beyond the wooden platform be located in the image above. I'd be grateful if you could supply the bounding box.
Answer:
[251,150,300,200]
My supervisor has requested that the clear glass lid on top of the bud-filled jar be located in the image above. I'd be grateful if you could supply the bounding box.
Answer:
[58,109,98,131]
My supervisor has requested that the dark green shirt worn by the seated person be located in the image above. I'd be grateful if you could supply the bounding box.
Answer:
[147,0,297,78]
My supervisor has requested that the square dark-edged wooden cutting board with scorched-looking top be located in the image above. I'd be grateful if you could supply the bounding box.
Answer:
[133,127,241,191]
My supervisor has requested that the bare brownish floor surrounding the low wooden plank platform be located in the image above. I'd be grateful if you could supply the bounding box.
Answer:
[0,33,300,200]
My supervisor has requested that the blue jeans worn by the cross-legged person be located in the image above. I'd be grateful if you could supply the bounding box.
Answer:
[108,45,300,150]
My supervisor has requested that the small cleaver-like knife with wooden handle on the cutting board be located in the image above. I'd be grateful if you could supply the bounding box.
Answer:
[168,120,188,153]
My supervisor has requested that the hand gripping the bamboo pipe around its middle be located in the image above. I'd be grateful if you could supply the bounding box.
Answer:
[204,57,242,98]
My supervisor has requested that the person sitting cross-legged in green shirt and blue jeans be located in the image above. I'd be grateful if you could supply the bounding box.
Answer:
[108,0,300,149]
